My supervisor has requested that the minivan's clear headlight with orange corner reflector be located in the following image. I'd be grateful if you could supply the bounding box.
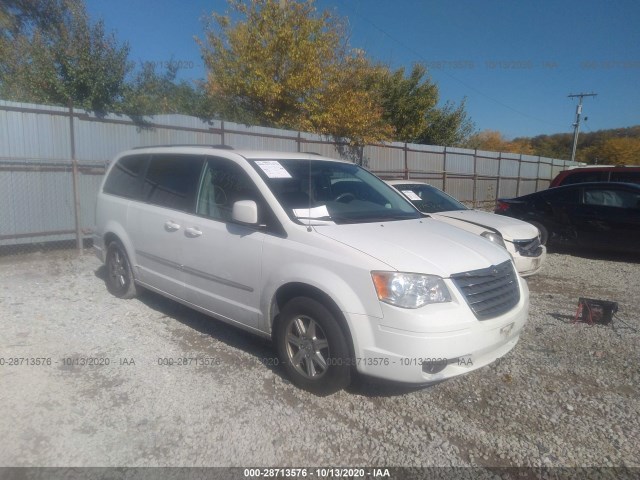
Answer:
[371,272,451,308]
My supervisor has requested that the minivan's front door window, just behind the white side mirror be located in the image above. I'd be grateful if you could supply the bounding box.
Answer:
[197,158,266,223]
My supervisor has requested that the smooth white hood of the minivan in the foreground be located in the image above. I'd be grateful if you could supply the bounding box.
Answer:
[314,218,511,278]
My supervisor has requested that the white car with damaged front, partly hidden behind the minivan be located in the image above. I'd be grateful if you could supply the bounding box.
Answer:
[387,180,547,277]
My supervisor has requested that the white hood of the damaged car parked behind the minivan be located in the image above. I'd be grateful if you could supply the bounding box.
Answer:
[429,210,538,241]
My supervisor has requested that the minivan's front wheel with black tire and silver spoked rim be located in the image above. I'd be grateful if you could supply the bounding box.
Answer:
[274,297,352,395]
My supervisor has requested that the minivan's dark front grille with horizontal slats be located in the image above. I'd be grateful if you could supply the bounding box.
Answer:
[451,261,520,320]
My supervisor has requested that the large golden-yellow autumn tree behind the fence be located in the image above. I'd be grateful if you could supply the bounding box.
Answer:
[200,0,392,145]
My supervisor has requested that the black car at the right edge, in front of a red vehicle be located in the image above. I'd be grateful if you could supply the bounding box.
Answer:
[495,182,640,253]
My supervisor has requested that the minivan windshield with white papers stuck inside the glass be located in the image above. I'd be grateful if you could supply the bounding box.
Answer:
[251,159,422,225]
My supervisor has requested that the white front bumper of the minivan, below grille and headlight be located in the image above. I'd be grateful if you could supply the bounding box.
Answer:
[347,279,529,384]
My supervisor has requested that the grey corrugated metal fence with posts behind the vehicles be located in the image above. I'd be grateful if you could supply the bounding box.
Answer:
[0,100,573,253]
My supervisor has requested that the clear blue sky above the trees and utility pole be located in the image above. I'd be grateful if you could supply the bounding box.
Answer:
[86,0,640,138]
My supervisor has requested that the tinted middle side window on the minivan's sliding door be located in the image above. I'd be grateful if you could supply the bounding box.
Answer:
[144,155,203,212]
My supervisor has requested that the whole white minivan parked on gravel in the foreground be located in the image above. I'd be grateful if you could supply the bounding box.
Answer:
[94,146,529,394]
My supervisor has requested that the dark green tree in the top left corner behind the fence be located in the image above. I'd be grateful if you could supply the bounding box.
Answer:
[0,0,131,111]
